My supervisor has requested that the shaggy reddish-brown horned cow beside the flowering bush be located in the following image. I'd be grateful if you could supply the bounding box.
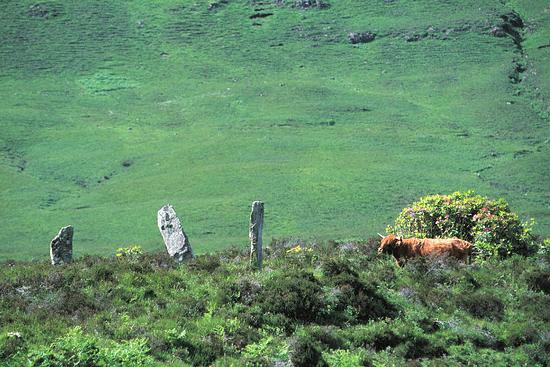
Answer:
[378,234,473,266]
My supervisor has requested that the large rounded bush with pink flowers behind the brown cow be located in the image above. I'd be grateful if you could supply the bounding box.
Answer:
[387,191,533,258]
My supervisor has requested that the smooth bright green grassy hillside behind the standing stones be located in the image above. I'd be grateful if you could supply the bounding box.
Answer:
[0,0,550,259]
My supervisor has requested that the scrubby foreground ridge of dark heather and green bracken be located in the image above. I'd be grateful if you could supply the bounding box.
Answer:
[0,239,550,367]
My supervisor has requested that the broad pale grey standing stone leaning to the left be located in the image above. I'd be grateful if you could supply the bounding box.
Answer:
[157,204,193,262]
